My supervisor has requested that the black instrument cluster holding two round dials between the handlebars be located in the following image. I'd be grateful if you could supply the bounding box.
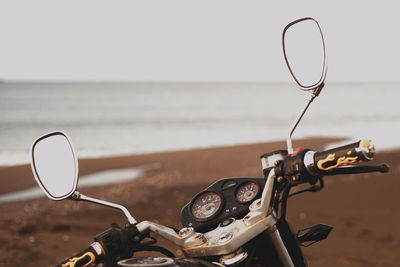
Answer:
[181,177,265,231]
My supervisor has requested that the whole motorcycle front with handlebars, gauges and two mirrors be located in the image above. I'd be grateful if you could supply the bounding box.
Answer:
[31,17,389,267]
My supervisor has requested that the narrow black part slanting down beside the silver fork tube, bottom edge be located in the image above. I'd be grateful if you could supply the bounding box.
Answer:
[276,219,307,267]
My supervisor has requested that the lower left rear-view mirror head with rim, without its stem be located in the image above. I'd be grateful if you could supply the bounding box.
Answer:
[31,132,78,200]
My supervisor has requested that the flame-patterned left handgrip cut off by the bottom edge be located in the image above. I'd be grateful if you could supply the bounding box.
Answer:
[56,242,102,267]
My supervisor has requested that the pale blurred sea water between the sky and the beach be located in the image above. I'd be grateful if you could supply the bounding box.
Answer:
[0,82,400,165]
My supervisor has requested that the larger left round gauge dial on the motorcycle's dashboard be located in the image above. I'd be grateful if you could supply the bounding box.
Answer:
[192,192,222,221]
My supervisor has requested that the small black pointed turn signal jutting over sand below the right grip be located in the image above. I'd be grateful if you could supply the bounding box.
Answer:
[297,224,333,247]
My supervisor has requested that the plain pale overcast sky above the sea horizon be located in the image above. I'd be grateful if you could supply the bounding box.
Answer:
[0,0,400,81]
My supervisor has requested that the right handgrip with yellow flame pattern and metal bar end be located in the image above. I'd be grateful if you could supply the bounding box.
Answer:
[313,140,375,173]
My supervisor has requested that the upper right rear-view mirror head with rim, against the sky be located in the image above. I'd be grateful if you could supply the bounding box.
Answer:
[282,18,326,90]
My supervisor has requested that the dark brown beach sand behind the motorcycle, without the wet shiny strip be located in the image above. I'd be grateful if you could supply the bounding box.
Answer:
[0,139,400,267]
